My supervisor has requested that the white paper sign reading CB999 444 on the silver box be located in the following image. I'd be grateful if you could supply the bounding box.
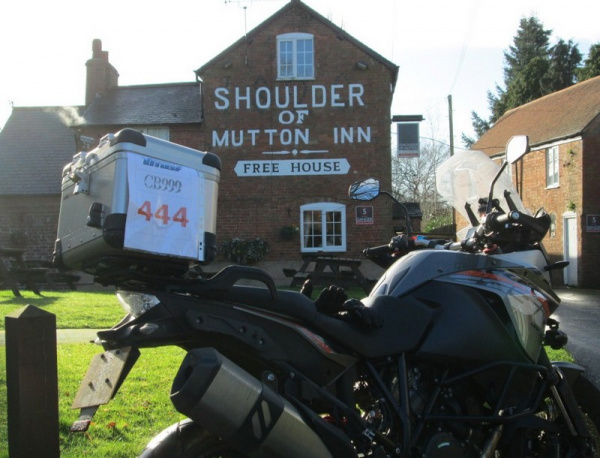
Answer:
[124,153,204,260]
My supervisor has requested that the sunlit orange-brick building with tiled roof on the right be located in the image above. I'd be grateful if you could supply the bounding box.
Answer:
[473,77,600,288]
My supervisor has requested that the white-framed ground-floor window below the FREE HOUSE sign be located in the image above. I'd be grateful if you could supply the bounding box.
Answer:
[300,202,346,252]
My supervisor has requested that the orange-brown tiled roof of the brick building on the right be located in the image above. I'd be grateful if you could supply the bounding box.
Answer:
[472,76,600,155]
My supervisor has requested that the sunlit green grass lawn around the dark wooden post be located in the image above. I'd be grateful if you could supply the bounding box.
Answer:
[0,288,571,458]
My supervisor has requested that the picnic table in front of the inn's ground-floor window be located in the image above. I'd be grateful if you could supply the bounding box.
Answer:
[284,253,373,294]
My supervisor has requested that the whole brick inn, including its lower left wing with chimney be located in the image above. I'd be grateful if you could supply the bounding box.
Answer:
[0,0,398,282]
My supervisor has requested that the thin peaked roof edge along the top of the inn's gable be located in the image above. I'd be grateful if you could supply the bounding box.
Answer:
[196,0,399,88]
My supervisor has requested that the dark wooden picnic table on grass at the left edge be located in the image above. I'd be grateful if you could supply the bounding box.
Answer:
[0,247,48,297]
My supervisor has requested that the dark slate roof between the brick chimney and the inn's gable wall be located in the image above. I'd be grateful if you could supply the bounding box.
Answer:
[82,82,202,126]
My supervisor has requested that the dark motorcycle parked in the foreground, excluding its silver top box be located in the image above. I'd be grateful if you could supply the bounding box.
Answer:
[69,137,599,458]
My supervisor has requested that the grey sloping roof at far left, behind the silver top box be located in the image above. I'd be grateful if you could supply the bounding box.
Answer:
[0,107,81,195]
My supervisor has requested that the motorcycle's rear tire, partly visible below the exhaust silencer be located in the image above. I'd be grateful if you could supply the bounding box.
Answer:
[139,419,245,458]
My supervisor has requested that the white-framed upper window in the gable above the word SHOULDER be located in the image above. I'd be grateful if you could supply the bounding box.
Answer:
[277,33,315,79]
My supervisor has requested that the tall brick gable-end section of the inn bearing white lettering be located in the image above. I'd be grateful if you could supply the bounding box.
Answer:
[196,1,397,272]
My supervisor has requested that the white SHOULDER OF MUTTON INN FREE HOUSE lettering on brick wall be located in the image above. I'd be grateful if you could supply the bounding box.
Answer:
[212,83,372,177]
